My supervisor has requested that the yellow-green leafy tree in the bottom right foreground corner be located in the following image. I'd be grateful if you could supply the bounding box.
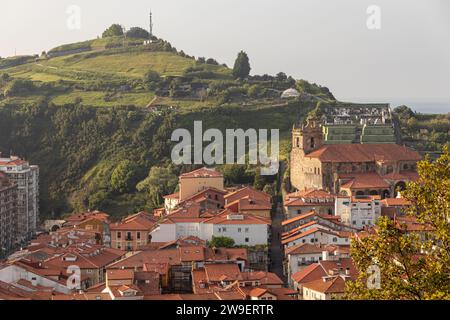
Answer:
[347,148,450,300]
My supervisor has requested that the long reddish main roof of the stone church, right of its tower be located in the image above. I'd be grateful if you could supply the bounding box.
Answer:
[306,144,422,162]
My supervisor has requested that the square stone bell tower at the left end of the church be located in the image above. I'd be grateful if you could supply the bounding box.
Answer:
[290,119,323,190]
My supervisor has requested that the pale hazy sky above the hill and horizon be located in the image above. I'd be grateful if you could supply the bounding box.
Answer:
[0,0,450,112]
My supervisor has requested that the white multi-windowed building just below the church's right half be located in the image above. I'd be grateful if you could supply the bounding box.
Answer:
[335,196,381,229]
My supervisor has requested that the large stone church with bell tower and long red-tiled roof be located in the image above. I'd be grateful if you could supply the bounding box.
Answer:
[290,119,421,198]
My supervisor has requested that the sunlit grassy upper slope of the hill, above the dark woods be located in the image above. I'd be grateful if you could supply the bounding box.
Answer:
[0,31,334,110]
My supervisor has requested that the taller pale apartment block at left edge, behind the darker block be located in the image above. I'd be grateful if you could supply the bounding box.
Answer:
[0,155,39,242]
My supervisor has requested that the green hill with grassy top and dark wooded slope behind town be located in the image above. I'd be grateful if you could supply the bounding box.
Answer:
[0,32,334,217]
